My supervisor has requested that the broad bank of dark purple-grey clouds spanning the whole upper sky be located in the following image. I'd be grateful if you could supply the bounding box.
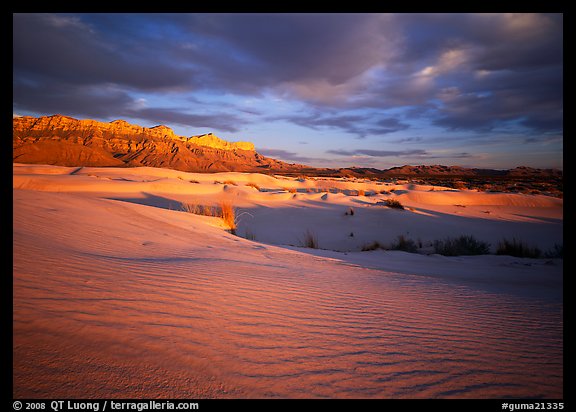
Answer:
[13,14,563,139]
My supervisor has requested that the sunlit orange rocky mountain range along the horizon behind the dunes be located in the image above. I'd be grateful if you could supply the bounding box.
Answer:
[12,115,562,177]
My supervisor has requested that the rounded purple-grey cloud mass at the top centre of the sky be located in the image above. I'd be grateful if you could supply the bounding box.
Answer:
[178,13,393,84]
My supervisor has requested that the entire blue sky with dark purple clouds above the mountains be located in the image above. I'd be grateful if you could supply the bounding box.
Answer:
[13,13,563,169]
